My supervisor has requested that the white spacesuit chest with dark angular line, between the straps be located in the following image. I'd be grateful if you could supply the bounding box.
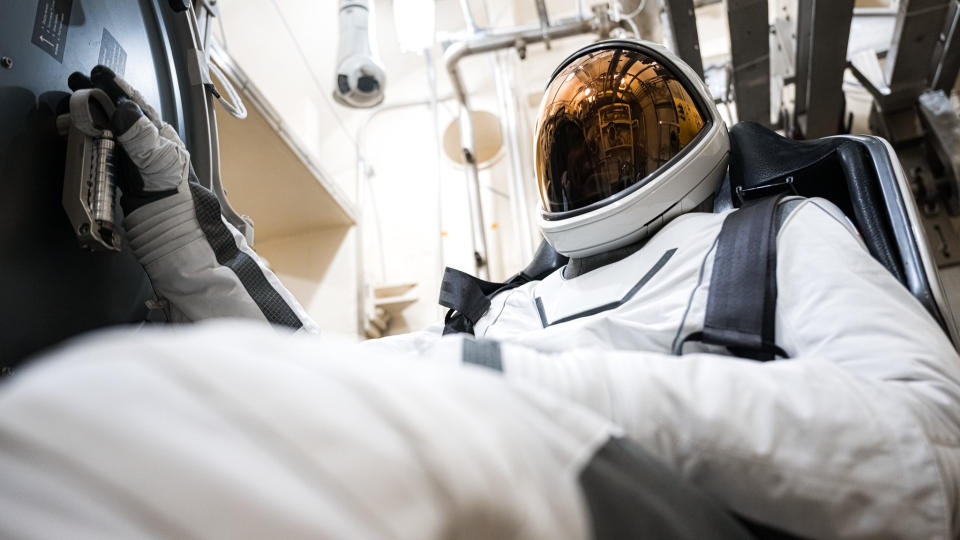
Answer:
[474,205,724,353]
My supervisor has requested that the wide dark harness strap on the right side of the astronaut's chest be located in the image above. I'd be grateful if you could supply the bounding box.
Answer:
[685,194,786,361]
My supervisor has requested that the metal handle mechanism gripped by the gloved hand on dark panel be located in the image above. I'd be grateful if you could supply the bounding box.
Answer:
[57,89,121,251]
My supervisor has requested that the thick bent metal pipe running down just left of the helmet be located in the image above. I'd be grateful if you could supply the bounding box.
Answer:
[443,11,615,279]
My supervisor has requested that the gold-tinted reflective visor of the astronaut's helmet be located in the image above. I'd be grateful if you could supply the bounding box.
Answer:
[536,49,704,212]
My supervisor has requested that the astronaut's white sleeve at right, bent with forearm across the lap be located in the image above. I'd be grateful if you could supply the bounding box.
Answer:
[454,204,960,538]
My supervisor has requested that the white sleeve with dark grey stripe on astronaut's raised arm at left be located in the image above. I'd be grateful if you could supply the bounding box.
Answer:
[124,181,319,333]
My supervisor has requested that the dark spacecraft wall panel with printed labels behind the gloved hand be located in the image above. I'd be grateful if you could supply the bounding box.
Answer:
[0,0,199,370]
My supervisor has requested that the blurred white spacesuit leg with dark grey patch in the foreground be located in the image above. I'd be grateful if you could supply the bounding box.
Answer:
[0,321,749,540]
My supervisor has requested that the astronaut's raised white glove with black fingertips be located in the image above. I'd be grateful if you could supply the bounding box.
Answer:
[67,65,195,215]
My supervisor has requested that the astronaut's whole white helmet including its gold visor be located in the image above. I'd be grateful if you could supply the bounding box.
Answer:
[534,40,730,257]
